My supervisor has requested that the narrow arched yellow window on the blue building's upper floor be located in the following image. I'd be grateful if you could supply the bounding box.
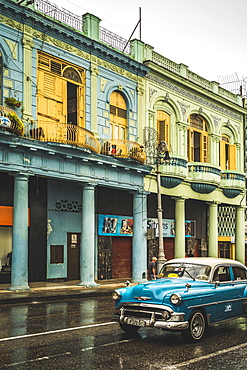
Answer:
[110,91,127,140]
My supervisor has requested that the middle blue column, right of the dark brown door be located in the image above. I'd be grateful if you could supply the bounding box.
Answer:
[79,184,98,287]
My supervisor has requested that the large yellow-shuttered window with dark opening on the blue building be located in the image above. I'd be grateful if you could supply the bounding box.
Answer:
[37,51,85,127]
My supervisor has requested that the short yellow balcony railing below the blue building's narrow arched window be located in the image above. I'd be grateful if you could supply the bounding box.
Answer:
[100,139,146,163]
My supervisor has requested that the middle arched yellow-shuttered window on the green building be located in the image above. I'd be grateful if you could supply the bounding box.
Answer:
[187,114,208,163]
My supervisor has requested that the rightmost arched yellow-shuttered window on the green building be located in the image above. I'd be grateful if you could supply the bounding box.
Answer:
[220,135,236,170]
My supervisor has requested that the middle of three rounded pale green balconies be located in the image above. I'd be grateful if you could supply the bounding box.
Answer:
[188,162,220,194]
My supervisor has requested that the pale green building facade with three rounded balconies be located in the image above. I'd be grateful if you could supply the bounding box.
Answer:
[142,45,246,263]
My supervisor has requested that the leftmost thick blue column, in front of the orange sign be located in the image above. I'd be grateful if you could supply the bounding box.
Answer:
[9,174,30,291]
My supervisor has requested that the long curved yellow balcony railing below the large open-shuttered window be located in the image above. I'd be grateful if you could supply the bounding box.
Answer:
[26,121,100,153]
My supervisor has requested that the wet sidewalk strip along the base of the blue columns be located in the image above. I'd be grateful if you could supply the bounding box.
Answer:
[0,278,132,306]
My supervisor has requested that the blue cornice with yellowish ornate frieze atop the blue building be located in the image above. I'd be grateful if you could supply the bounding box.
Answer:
[0,8,148,77]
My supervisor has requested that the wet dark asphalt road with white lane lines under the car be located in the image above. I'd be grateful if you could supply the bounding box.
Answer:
[0,297,247,370]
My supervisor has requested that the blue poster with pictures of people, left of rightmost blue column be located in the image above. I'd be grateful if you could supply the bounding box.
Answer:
[98,215,133,236]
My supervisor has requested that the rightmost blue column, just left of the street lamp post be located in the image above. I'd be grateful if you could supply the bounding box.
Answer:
[132,192,147,283]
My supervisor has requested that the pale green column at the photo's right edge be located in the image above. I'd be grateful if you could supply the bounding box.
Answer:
[235,207,245,264]
